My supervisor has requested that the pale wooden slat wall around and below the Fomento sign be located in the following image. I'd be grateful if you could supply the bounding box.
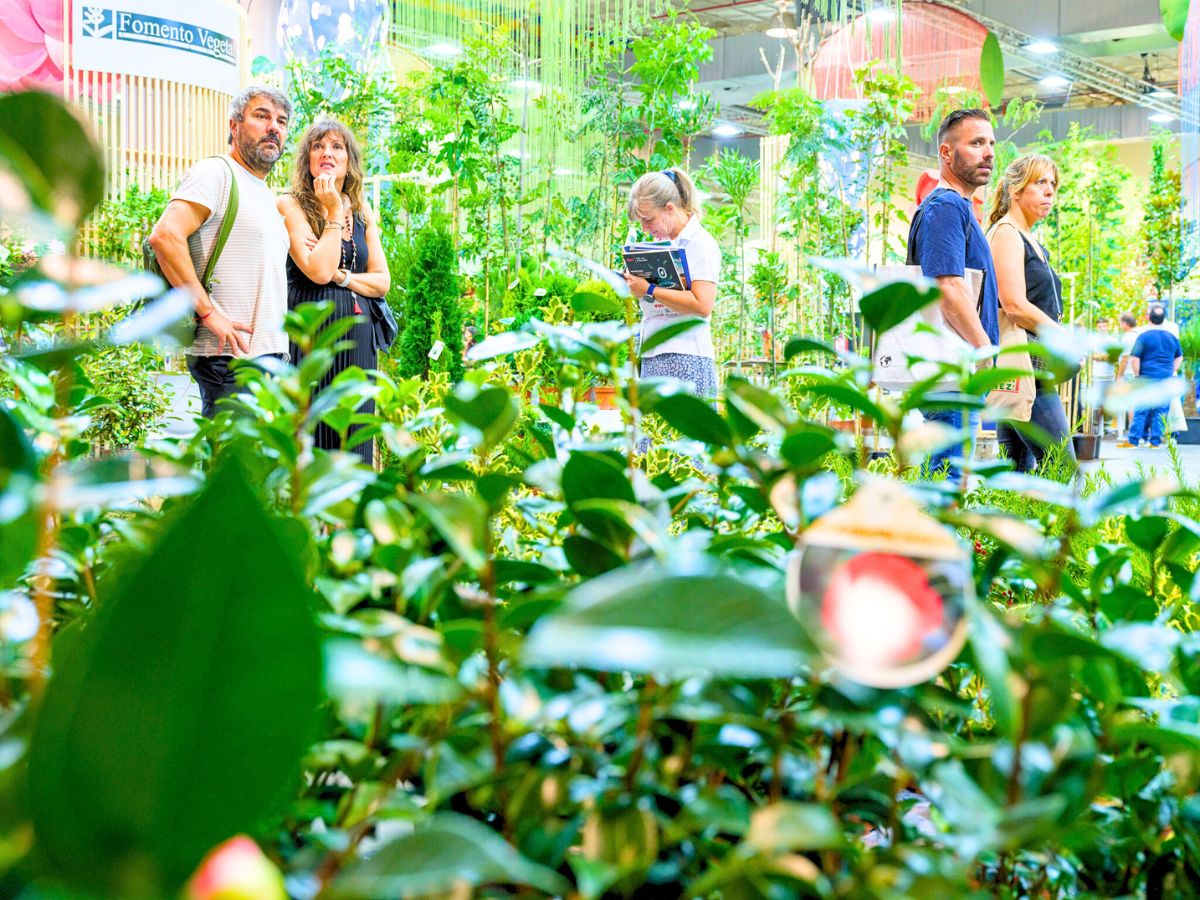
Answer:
[62,0,250,197]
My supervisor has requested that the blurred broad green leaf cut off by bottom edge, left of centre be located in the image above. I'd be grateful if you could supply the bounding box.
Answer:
[325,812,571,900]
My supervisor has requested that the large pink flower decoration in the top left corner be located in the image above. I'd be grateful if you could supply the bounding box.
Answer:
[0,0,64,90]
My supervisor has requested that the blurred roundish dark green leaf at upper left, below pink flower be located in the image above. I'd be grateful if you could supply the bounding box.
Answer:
[0,90,104,228]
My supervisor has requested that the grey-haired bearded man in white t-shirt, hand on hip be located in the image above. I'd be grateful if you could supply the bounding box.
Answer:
[150,86,292,419]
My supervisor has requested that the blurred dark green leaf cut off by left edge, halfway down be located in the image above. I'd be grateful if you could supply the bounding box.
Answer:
[0,404,38,586]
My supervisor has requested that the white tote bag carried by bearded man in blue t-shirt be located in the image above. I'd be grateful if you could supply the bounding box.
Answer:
[871,265,983,391]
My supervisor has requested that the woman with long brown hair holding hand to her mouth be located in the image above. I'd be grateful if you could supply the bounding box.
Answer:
[278,119,391,466]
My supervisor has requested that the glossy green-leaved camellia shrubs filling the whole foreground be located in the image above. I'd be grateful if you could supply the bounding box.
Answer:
[0,95,1200,898]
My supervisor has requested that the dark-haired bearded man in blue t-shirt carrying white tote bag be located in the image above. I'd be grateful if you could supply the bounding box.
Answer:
[908,109,1000,476]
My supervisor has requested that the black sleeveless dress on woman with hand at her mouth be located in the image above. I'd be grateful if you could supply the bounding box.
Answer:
[288,216,378,466]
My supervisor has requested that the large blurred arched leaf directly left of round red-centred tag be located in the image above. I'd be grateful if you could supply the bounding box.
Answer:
[524,557,810,678]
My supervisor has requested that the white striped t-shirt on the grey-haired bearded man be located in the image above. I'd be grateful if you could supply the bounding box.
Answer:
[172,157,288,356]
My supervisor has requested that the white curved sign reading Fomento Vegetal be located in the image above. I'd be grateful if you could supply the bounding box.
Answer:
[71,0,241,94]
